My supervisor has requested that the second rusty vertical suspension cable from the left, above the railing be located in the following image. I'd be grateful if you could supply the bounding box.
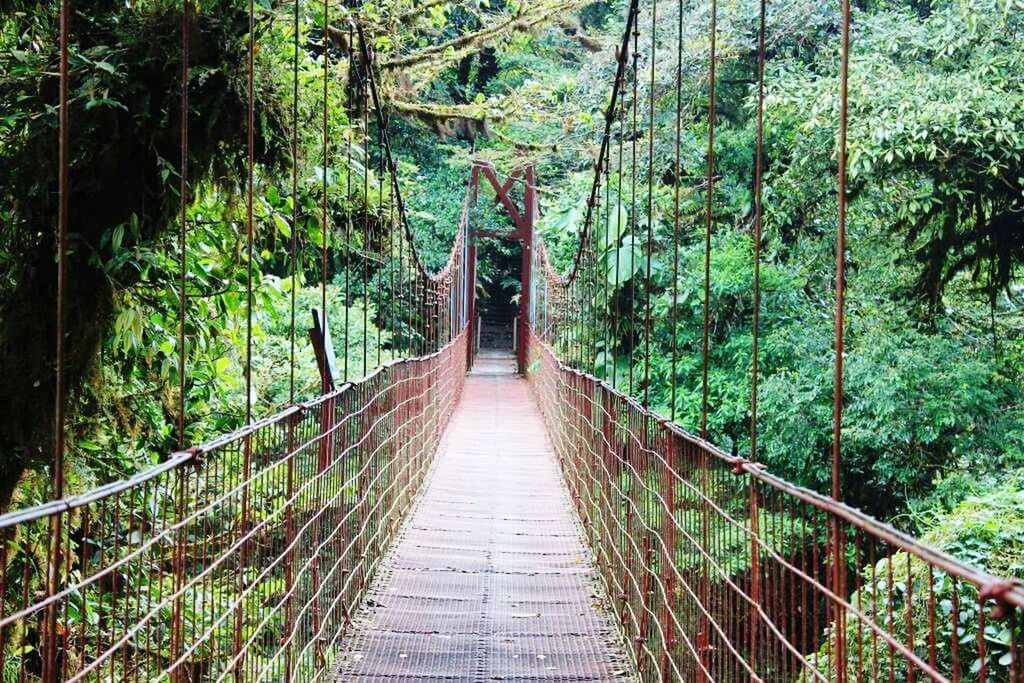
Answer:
[177,0,191,449]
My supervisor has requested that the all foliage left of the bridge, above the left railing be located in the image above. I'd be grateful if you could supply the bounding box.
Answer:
[0,0,407,507]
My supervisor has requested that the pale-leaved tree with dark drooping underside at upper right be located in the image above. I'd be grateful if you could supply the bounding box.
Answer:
[767,0,1024,304]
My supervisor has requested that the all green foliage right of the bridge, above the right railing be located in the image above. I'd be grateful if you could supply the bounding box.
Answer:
[543,0,1024,518]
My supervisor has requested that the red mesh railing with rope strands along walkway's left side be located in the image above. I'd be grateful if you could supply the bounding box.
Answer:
[0,332,467,681]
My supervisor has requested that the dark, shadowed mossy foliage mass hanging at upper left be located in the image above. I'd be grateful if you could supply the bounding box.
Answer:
[0,0,286,506]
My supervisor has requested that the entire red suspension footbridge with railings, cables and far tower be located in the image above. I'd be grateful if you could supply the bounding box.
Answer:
[0,0,1024,683]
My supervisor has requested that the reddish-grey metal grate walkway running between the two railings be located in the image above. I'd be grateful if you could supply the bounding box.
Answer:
[335,355,632,681]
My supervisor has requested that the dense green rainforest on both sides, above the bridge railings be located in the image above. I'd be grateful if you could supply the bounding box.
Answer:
[0,0,1024,666]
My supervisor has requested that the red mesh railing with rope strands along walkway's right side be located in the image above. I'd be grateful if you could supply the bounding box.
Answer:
[528,335,1024,682]
